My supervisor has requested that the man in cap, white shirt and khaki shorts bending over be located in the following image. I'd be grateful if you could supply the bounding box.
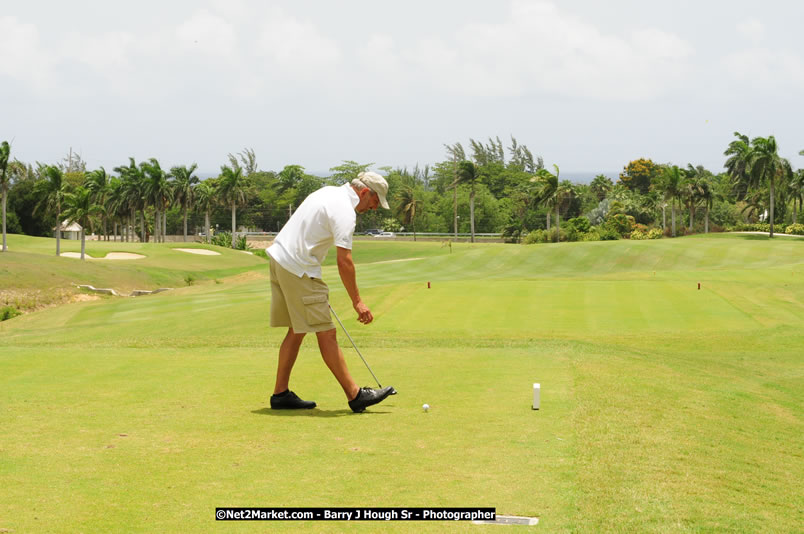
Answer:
[266,172,394,412]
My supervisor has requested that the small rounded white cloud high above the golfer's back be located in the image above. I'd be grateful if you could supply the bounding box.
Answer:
[257,7,342,79]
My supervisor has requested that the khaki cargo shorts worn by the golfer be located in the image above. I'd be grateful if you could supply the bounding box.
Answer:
[271,259,335,334]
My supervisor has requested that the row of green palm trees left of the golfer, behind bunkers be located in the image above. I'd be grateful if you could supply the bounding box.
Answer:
[0,148,251,259]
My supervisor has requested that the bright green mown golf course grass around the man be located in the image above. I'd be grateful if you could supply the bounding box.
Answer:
[0,235,804,533]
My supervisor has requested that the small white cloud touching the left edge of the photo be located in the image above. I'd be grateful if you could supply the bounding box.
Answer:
[0,16,52,90]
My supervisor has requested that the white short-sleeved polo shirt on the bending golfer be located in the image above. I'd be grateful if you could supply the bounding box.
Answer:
[265,184,360,278]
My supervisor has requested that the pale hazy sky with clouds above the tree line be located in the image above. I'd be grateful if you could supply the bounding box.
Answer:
[0,0,804,180]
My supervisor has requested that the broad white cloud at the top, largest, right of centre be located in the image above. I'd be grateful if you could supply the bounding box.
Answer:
[354,0,694,100]
